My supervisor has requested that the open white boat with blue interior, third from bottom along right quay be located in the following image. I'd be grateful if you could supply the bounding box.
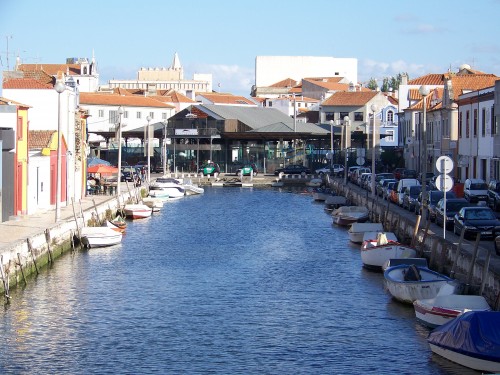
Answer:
[384,264,457,304]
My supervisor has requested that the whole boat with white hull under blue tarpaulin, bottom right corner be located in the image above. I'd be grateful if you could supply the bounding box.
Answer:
[427,311,500,373]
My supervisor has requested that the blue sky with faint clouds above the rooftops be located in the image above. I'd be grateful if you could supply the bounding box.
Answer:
[0,0,500,96]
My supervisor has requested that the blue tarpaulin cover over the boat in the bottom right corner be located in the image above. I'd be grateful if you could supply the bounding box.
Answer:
[427,311,500,362]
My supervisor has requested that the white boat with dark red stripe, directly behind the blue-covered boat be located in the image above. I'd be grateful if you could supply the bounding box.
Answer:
[413,285,491,328]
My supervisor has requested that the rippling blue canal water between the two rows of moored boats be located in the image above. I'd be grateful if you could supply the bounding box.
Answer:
[0,188,475,374]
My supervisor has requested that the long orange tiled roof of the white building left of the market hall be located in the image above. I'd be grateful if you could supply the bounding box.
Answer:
[80,92,174,108]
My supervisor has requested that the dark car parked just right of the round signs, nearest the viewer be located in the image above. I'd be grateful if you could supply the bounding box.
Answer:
[453,206,500,239]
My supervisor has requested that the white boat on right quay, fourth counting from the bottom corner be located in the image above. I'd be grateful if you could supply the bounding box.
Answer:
[361,232,417,270]
